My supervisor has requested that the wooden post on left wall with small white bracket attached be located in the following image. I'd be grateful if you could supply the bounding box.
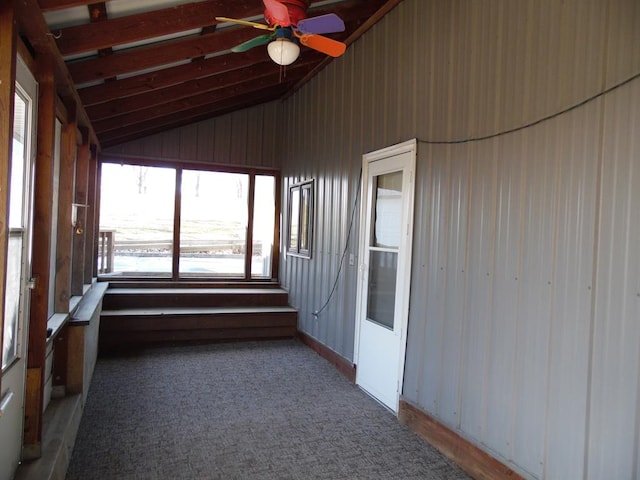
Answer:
[71,143,91,296]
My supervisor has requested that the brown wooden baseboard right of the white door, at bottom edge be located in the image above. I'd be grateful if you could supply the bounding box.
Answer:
[398,400,524,480]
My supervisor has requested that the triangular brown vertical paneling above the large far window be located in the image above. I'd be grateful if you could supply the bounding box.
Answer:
[105,102,282,168]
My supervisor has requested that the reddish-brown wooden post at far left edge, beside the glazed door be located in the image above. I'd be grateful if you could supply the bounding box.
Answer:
[0,0,17,398]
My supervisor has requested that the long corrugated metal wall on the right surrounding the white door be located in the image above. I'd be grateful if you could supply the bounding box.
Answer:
[281,0,640,479]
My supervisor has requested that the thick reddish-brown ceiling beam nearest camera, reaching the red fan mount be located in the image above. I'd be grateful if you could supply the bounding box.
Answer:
[56,0,264,56]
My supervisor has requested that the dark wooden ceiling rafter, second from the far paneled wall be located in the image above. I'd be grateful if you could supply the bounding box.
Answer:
[94,71,305,135]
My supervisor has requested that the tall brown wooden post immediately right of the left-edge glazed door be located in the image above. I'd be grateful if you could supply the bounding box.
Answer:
[24,57,56,459]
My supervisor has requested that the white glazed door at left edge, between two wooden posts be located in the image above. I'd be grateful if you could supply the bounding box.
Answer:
[0,59,37,479]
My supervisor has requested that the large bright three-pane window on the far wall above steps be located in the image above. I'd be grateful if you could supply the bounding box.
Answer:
[99,161,280,280]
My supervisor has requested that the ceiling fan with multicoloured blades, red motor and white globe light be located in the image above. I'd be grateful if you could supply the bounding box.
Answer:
[216,0,347,65]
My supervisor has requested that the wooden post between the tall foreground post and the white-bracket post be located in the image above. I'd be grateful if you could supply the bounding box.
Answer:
[55,113,77,313]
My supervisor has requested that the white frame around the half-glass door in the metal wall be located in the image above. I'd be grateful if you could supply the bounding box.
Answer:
[353,138,417,413]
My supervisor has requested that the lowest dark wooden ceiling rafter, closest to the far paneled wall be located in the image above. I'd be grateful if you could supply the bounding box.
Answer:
[100,83,291,148]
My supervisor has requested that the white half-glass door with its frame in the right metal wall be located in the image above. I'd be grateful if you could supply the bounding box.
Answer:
[355,140,416,412]
